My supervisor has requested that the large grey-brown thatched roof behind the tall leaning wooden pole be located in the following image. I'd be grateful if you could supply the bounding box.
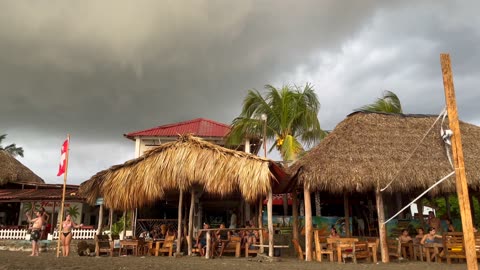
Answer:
[289,112,480,193]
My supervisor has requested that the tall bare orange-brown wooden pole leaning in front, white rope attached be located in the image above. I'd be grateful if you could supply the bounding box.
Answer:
[440,54,478,270]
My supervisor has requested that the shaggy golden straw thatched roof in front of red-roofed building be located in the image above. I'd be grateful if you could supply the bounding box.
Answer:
[80,135,286,210]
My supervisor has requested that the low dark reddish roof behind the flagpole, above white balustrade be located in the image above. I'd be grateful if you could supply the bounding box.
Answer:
[0,189,84,201]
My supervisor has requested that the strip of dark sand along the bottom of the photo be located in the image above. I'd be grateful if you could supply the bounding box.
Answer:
[0,251,467,270]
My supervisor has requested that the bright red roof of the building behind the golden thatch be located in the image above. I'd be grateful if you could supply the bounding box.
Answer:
[124,118,230,139]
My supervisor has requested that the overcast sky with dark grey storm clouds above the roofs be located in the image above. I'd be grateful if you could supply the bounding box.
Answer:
[0,0,480,184]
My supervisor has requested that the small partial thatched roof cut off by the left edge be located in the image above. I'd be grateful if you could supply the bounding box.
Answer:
[0,150,45,186]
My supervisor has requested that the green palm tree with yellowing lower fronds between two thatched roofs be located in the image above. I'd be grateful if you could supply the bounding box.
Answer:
[227,83,325,215]
